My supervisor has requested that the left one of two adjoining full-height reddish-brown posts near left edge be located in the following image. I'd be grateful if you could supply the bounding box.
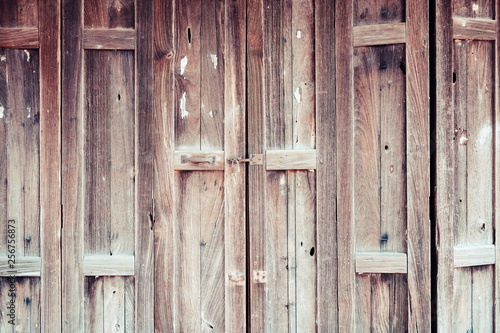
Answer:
[39,0,61,332]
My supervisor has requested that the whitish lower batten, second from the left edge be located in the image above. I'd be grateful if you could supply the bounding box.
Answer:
[83,255,134,276]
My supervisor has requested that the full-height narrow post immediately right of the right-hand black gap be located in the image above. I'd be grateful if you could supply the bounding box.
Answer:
[436,0,455,332]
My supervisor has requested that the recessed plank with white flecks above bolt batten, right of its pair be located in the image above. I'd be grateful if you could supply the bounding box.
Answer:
[200,0,224,150]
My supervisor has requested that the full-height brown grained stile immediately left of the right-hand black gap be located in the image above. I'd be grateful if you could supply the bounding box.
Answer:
[406,1,430,331]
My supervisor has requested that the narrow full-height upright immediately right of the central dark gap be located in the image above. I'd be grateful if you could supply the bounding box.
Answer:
[246,0,266,332]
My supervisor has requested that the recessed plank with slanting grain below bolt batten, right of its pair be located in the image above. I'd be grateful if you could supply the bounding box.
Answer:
[199,172,226,332]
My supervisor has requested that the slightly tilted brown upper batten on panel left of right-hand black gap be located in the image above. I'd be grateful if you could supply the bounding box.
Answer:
[353,22,406,47]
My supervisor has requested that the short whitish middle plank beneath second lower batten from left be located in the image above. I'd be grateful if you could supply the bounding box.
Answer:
[103,276,125,332]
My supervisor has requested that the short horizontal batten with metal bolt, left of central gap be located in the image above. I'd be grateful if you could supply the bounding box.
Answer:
[174,151,224,170]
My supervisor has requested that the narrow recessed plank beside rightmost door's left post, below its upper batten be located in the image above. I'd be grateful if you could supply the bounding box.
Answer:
[452,40,472,331]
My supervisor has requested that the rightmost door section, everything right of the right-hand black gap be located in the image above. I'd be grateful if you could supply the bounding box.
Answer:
[435,0,500,332]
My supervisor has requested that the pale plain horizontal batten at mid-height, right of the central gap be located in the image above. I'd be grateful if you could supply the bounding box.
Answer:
[266,150,316,170]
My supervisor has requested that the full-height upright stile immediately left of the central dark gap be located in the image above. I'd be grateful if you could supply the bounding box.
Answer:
[224,0,246,332]
